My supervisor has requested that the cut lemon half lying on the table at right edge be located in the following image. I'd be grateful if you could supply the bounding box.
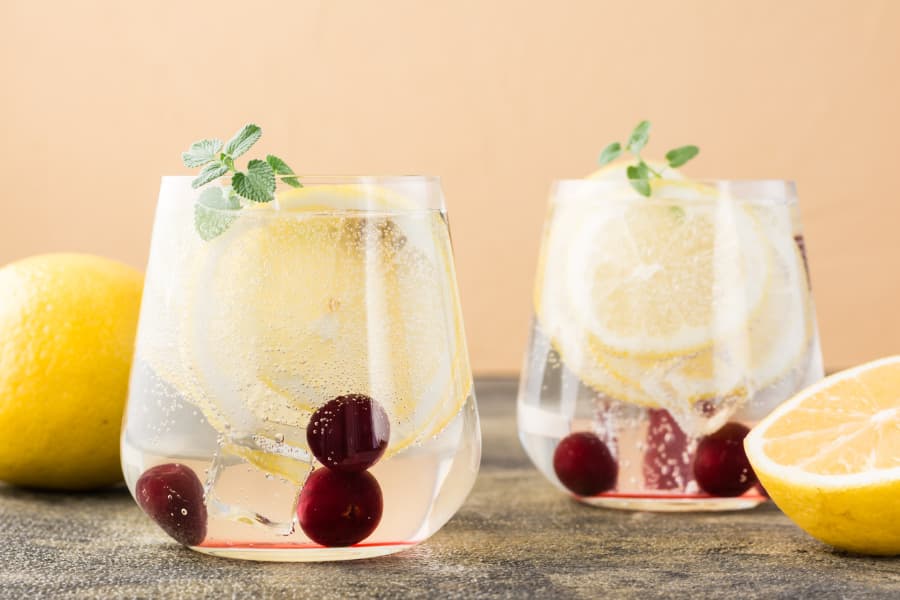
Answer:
[744,356,900,555]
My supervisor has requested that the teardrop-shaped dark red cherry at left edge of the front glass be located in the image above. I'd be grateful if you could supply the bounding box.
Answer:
[135,463,206,546]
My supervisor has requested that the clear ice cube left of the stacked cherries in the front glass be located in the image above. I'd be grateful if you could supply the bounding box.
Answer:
[205,433,313,535]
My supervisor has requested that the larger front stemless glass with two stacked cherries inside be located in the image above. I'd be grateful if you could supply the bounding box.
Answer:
[122,177,481,561]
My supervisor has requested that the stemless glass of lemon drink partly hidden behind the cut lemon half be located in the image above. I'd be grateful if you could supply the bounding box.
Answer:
[518,180,823,510]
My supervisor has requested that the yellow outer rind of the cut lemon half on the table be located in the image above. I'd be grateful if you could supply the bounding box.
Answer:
[757,472,900,556]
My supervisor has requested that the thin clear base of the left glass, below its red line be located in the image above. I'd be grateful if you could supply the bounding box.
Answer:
[190,542,416,562]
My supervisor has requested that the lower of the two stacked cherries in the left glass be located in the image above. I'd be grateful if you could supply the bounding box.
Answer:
[297,469,382,546]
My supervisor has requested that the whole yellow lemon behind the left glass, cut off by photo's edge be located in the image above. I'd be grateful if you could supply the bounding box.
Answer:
[0,254,143,490]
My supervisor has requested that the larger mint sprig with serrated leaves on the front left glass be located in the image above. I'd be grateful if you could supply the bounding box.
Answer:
[181,124,303,240]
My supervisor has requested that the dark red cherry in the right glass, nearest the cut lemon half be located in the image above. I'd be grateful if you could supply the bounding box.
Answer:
[694,423,756,496]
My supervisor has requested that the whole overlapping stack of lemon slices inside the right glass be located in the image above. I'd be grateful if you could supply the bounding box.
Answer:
[535,169,814,422]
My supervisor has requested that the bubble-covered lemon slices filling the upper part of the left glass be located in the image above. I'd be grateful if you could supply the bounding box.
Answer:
[179,186,471,460]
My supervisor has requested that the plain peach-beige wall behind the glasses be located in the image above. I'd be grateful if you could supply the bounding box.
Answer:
[0,0,900,373]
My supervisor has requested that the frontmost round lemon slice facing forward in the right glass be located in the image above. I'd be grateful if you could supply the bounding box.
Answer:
[564,183,769,356]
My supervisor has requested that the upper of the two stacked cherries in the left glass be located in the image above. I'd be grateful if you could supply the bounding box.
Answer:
[306,394,391,472]
